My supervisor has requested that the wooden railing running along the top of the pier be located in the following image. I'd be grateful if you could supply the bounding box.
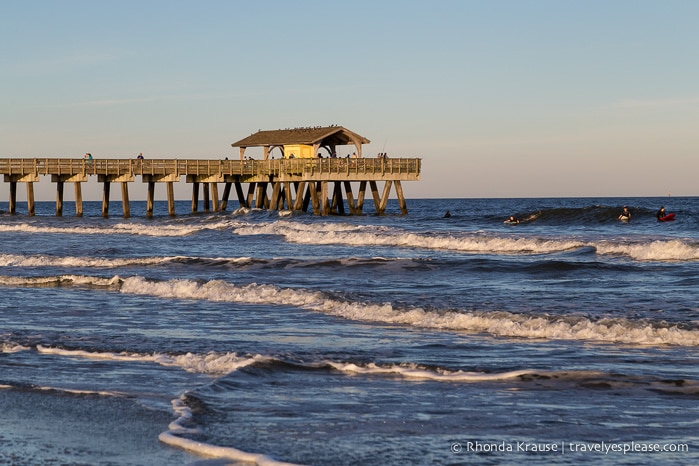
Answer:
[0,158,421,179]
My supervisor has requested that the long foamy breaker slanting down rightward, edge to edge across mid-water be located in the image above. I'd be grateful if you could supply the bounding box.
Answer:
[0,275,699,346]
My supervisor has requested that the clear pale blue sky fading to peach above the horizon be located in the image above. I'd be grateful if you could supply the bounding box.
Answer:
[0,0,699,200]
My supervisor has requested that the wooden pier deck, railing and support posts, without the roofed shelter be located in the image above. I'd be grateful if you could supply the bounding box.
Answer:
[0,157,421,217]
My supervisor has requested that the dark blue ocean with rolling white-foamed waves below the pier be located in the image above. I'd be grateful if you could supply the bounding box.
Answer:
[0,197,699,466]
